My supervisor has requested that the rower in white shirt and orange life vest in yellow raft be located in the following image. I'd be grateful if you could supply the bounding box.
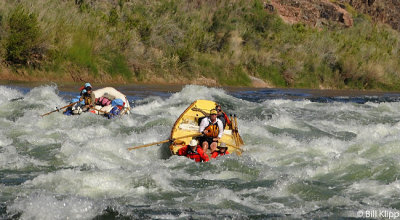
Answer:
[199,109,224,153]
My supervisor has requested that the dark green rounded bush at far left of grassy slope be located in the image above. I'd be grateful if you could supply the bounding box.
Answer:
[6,5,40,64]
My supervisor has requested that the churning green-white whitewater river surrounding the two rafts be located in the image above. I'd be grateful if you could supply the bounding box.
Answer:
[0,85,400,220]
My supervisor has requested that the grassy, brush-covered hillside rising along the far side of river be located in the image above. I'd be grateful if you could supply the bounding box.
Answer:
[0,0,400,91]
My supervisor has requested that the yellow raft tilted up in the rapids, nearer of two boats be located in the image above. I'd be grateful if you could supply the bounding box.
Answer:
[169,100,244,155]
